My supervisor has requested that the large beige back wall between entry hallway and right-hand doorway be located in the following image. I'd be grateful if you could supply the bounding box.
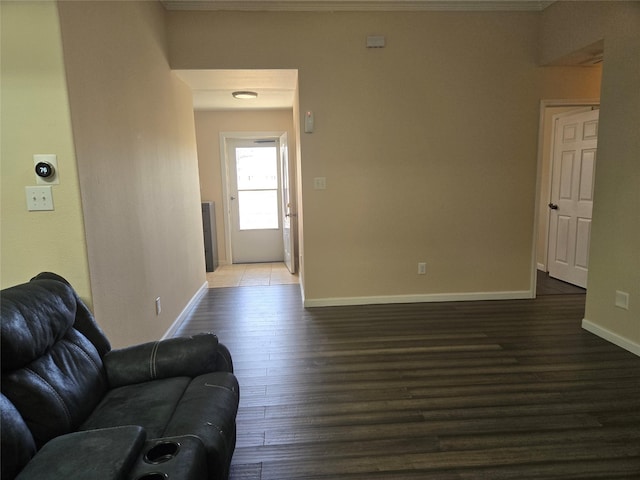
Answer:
[168,12,608,304]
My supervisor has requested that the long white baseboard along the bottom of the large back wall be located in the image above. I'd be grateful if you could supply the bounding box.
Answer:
[303,290,534,308]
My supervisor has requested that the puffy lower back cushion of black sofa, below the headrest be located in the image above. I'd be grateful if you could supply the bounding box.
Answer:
[2,328,107,448]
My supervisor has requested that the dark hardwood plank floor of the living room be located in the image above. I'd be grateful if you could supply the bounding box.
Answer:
[178,285,640,480]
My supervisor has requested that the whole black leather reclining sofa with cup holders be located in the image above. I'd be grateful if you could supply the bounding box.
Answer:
[0,273,239,480]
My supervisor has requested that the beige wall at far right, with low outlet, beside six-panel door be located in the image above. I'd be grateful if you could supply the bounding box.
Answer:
[542,2,640,354]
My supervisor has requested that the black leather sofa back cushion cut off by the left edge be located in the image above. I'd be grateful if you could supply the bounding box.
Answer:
[0,393,36,479]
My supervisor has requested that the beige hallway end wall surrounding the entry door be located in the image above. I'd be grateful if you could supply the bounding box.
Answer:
[195,110,296,264]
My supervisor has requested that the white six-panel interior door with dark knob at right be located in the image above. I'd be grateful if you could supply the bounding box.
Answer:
[548,110,599,288]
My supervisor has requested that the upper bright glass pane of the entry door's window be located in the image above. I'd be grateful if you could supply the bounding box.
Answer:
[236,147,278,190]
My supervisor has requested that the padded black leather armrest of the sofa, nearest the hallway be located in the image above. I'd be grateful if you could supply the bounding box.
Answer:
[103,333,218,388]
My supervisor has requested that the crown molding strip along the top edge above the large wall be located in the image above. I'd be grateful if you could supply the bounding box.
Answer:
[161,0,554,12]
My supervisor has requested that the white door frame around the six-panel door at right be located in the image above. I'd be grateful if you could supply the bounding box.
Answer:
[530,98,600,298]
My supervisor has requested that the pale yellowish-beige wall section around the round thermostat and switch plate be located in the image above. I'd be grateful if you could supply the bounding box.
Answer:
[0,2,91,304]
